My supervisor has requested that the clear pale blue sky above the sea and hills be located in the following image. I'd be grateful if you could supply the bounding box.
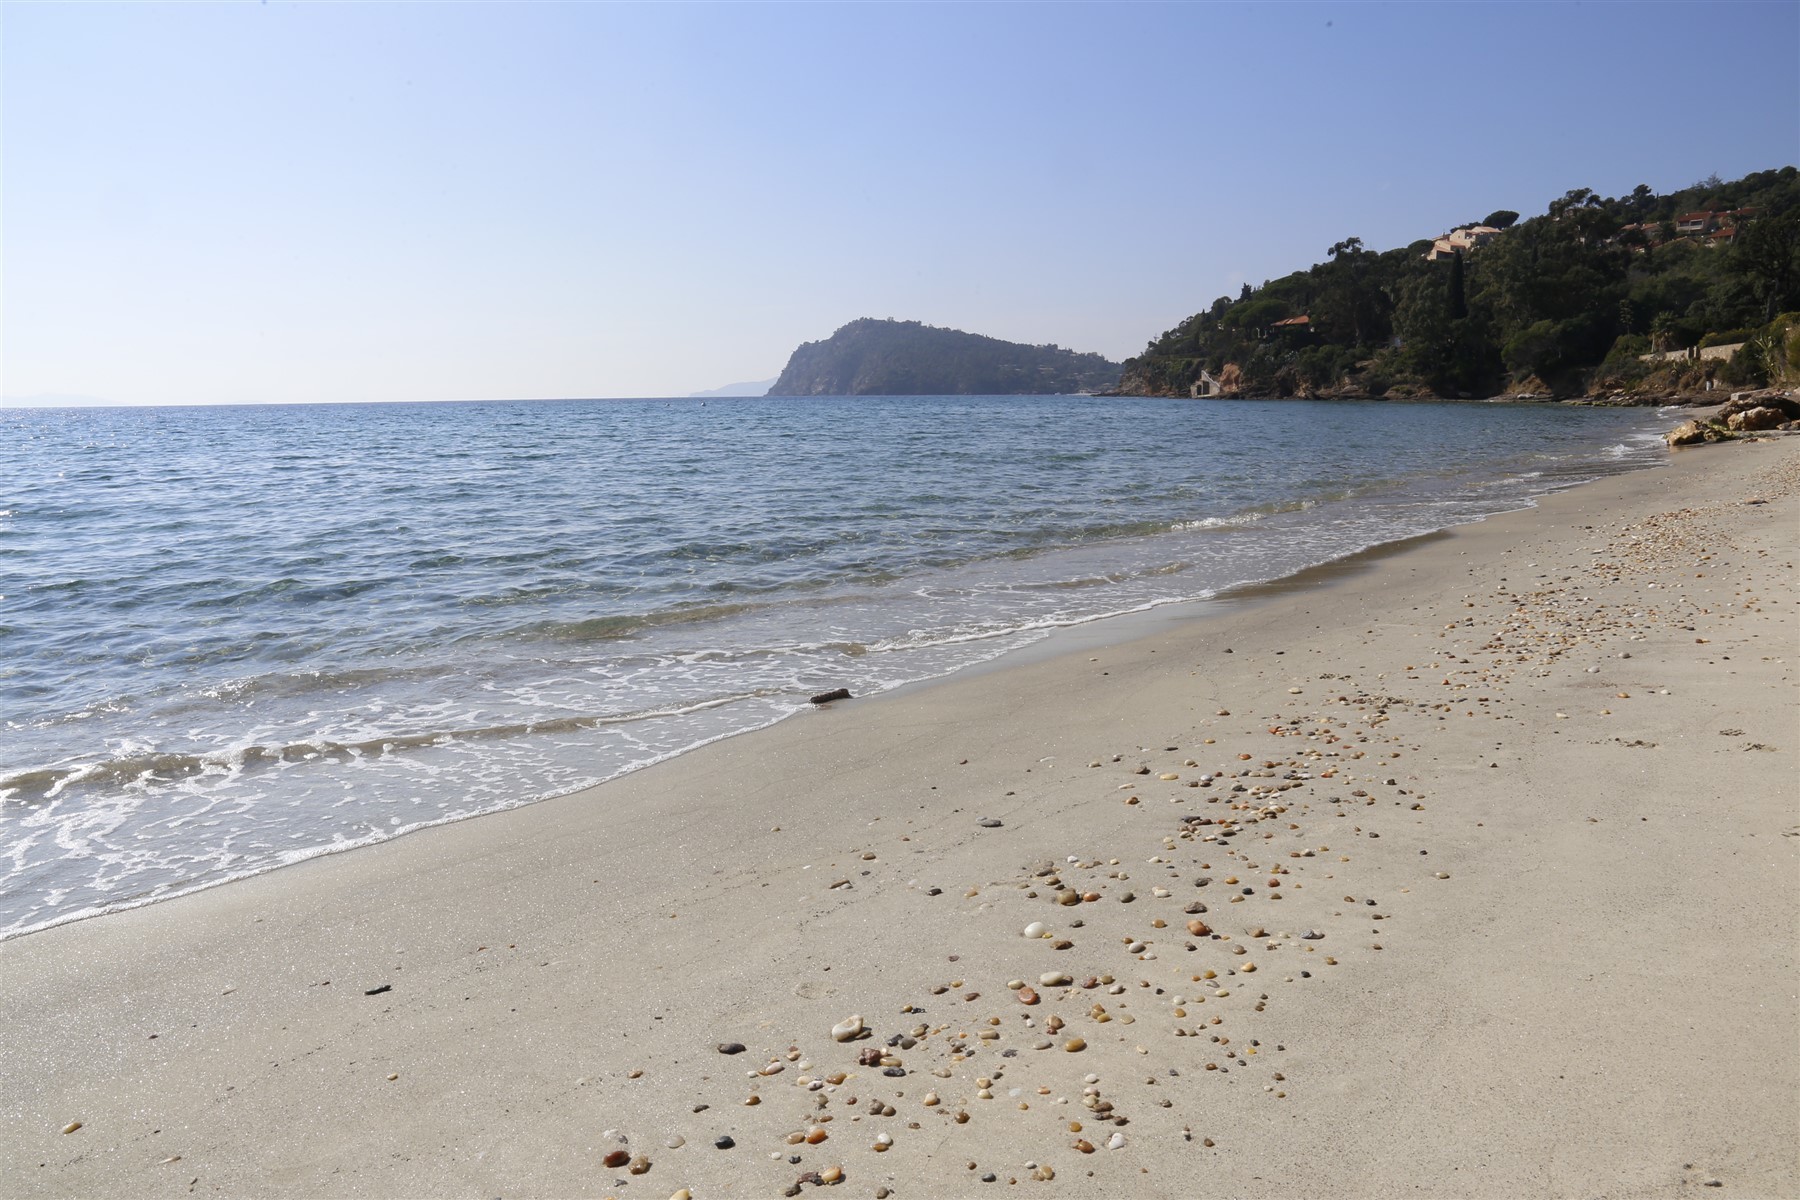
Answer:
[0,0,1800,403]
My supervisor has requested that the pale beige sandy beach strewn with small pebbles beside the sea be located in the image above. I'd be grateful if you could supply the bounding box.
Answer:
[0,439,1800,1198]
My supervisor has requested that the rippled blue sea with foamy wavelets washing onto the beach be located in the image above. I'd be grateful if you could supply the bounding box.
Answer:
[0,398,1667,937]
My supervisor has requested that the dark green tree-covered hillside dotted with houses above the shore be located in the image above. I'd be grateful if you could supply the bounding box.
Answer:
[1118,167,1800,399]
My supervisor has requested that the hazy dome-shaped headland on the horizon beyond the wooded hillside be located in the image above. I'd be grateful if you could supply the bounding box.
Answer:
[769,318,1121,396]
